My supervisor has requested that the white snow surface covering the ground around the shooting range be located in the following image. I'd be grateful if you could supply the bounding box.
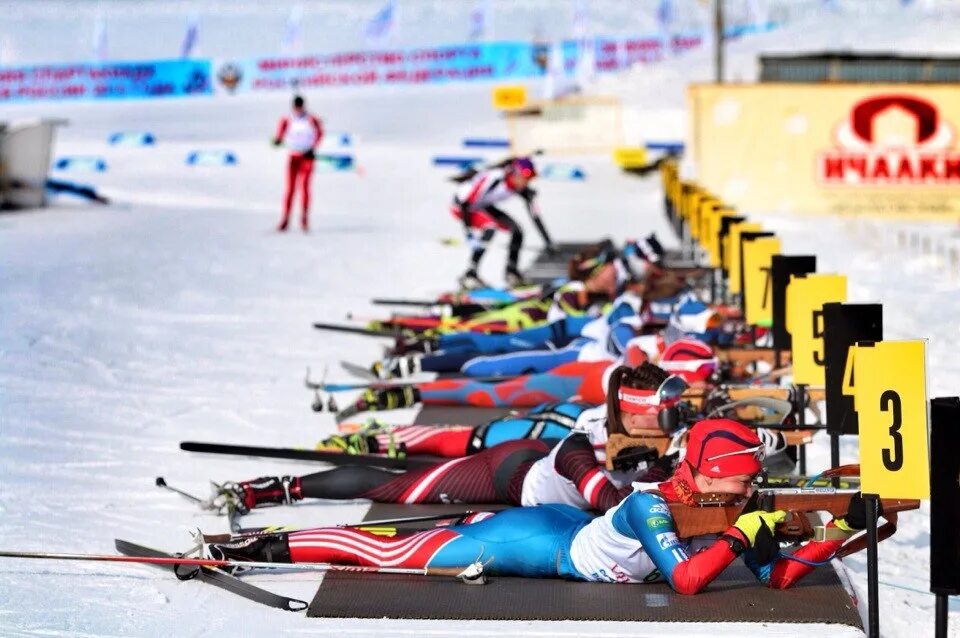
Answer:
[0,3,960,636]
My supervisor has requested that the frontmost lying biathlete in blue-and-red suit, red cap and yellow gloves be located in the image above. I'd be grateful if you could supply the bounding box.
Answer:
[207,420,866,594]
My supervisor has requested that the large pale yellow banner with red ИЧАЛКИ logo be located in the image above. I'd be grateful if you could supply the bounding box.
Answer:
[688,82,960,220]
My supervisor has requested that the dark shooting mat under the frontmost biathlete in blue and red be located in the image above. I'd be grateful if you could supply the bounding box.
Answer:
[307,503,862,629]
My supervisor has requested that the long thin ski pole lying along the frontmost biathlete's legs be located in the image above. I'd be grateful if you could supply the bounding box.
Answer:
[0,551,486,585]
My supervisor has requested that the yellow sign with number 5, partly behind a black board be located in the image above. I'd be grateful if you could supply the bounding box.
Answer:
[786,274,847,386]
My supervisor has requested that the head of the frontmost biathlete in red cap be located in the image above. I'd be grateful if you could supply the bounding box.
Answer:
[675,419,764,496]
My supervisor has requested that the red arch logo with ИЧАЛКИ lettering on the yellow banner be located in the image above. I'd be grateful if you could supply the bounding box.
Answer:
[817,94,960,186]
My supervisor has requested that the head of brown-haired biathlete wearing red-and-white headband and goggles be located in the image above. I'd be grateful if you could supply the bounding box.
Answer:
[607,361,687,435]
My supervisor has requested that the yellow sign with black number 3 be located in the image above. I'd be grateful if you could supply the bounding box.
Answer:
[851,341,930,499]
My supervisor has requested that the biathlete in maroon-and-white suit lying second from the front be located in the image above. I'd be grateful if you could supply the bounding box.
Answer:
[215,363,796,512]
